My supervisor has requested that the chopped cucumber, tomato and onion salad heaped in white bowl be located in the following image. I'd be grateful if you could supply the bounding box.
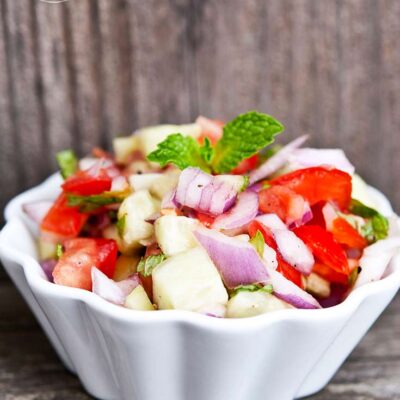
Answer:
[24,111,399,318]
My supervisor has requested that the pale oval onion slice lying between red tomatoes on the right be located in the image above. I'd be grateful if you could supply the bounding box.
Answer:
[272,229,314,275]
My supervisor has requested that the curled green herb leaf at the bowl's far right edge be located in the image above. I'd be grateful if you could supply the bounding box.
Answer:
[350,199,389,242]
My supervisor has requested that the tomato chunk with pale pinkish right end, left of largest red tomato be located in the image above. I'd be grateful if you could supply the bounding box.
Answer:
[259,185,310,224]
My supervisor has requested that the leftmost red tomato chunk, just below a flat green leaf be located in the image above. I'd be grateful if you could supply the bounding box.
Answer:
[40,194,88,239]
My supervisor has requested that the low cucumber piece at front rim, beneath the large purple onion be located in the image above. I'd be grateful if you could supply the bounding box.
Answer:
[226,291,293,318]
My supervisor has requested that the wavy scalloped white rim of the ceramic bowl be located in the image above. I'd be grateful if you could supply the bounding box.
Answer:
[0,173,400,333]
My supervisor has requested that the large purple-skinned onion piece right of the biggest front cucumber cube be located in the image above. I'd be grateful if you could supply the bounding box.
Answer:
[193,228,268,289]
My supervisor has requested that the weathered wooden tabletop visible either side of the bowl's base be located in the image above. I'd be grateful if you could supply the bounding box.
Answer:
[0,279,400,400]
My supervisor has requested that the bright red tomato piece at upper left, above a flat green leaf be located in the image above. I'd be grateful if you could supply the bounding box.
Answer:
[61,168,112,196]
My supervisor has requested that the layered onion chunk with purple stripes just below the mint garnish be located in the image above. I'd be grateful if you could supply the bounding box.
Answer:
[175,167,244,219]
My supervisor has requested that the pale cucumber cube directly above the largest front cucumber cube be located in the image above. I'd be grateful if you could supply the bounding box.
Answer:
[154,215,198,256]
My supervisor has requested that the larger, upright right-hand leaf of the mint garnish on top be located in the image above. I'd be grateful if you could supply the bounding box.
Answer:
[211,111,284,174]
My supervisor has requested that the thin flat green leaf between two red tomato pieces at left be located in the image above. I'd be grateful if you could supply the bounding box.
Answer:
[67,190,130,213]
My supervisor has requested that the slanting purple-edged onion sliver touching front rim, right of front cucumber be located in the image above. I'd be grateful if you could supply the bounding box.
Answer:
[267,267,321,309]
